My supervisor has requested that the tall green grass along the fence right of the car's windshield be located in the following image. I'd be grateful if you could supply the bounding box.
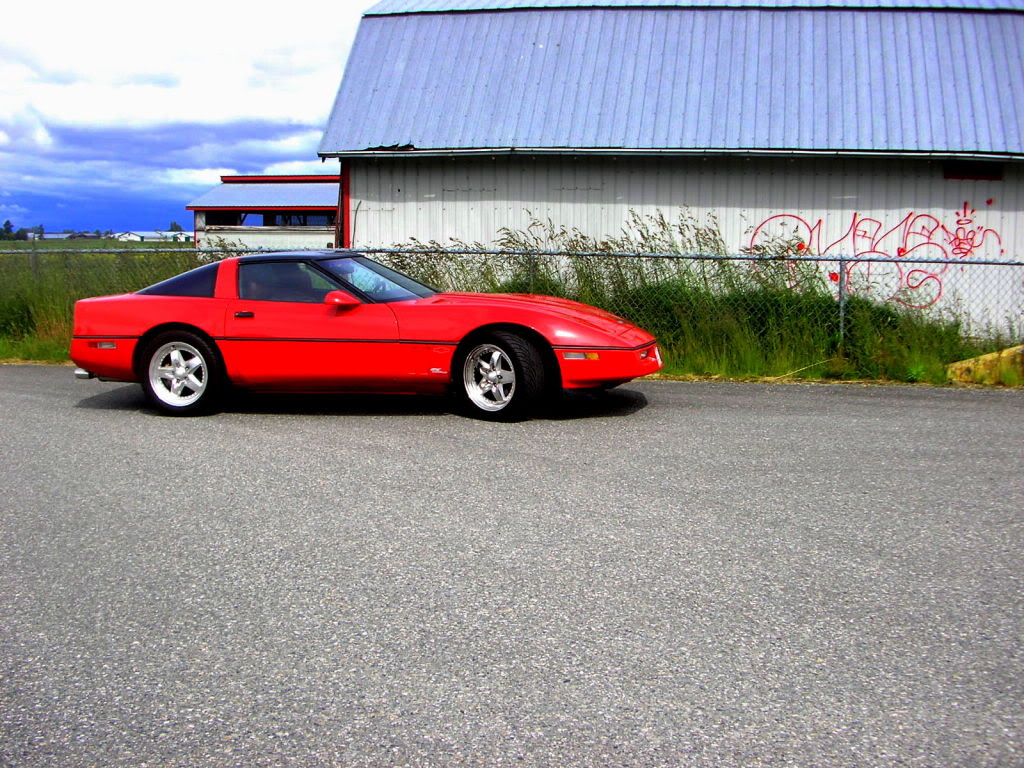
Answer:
[392,211,1013,383]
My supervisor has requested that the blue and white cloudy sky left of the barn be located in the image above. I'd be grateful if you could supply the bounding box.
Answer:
[0,0,374,231]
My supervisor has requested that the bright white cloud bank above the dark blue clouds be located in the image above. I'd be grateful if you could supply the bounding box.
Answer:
[0,0,373,125]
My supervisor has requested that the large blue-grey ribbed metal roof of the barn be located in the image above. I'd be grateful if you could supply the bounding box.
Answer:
[319,0,1024,157]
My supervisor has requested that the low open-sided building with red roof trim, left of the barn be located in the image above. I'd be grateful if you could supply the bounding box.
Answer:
[187,175,341,248]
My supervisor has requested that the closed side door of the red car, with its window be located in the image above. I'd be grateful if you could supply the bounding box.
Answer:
[221,261,399,391]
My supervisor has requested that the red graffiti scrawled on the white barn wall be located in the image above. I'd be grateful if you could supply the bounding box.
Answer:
[750,200,1006,308]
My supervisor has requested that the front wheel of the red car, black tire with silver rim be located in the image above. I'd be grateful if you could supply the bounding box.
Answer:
[453,331,546,421]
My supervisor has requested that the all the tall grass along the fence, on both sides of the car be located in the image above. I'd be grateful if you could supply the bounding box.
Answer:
[0,225,1020,383]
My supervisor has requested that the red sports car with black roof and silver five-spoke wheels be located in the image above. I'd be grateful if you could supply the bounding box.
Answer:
[71,251,662,420]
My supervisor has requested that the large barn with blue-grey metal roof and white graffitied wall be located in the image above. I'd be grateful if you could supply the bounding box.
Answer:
[318,0,1024,280]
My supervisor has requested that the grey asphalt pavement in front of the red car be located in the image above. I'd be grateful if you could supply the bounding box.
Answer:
[0,366,1024,768]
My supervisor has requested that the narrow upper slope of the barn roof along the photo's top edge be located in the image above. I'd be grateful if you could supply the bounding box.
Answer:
[365,0,1024,15]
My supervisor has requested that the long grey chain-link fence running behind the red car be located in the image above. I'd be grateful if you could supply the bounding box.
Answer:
[0,248,1024,383]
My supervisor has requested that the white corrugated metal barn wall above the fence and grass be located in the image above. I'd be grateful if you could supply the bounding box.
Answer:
[350,157,1024,259]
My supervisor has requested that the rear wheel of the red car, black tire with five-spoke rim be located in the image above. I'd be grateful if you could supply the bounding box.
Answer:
[138,331,224,416]
